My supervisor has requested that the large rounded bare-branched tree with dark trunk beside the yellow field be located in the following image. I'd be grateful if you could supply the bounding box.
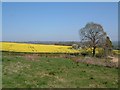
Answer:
[80,22,107,56]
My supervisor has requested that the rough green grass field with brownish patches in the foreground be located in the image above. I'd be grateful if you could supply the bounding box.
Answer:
[2,52,118,88]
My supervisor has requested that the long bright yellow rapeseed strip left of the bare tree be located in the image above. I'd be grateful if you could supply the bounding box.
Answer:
[0,42,79,53]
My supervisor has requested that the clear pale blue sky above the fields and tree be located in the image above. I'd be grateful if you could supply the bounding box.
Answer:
[2,2,118,41]
